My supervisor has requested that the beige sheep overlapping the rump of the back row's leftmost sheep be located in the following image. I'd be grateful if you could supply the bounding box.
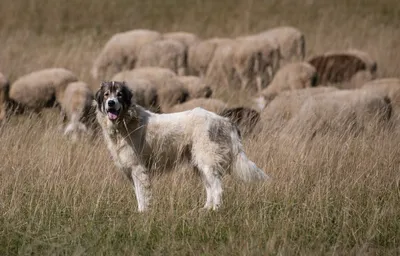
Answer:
[136,39,187,76]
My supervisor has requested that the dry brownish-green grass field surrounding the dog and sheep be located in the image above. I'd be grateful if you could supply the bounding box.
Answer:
[0,0,400,255]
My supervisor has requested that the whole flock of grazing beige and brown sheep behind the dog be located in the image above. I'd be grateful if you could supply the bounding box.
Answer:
[0,26,400,142]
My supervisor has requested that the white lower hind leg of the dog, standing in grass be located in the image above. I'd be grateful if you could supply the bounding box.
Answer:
[199,166,222,210]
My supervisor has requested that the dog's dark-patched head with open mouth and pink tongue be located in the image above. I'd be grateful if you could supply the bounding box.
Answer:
[95,81,133,122]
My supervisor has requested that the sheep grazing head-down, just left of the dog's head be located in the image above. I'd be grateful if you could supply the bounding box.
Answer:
[60,81,96,141]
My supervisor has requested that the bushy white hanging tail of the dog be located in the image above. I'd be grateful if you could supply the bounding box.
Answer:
[231,126,270,182]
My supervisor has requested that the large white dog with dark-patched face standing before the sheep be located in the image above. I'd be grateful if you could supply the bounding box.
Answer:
[94,81,269,212]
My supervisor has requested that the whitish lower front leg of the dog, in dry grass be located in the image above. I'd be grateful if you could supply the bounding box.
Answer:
[131,165,151,212]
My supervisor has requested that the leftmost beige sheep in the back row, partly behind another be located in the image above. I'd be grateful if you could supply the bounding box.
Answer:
[91,29,162,79]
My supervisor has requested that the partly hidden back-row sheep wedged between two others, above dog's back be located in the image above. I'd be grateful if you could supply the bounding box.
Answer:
[188,37,232,78]
